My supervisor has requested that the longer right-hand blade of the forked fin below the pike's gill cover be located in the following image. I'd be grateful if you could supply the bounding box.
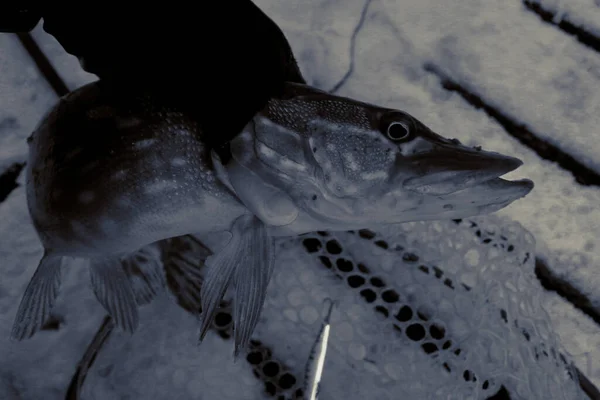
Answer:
[233,217,275,359]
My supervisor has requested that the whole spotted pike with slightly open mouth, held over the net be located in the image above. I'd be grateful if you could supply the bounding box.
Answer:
[12,82,533,356]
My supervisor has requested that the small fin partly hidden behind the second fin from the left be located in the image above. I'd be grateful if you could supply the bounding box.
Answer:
[122,244,165,305]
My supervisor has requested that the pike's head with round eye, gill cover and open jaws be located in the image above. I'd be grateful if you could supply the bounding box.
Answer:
[220,84,533,234]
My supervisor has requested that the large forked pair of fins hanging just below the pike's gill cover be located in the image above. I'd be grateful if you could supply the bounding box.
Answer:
[200,215,274,359]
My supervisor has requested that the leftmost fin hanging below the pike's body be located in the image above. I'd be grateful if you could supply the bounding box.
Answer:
[11,251,62,340]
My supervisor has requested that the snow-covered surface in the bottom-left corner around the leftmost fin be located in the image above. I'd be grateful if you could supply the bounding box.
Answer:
[0,179,104,400]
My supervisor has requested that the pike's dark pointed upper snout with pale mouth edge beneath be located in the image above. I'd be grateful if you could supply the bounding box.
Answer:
[403,141,523,195]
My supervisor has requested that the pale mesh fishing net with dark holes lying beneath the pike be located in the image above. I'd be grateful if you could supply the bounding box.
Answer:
[82,216,585,400]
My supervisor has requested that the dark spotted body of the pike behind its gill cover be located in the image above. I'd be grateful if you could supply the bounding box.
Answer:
[27,83,245,255]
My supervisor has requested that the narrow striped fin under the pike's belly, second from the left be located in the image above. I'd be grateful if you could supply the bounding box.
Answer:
[90,257,139,334]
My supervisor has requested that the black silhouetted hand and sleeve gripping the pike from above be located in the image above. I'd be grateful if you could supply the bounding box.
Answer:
[0,0,304,147]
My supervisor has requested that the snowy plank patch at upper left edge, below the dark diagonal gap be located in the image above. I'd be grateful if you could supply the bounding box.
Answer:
[0,34,56,175]
